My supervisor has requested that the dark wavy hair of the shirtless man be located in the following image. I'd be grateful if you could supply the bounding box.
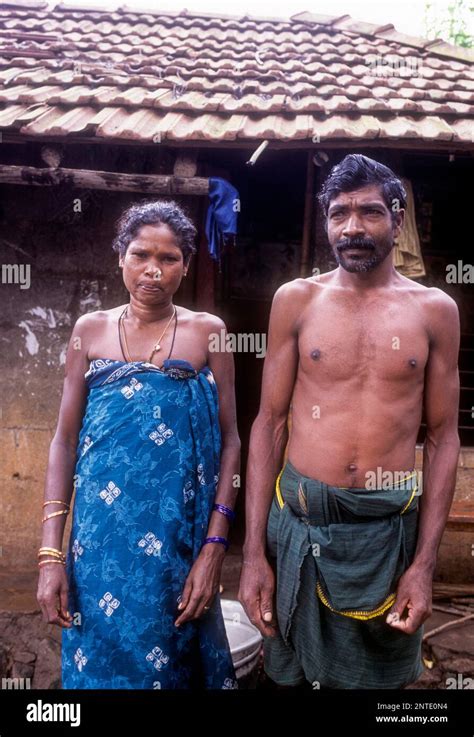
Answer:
[318,154,407,218]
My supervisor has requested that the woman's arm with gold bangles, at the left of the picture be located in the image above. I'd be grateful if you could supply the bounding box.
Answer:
[37,315,92,626]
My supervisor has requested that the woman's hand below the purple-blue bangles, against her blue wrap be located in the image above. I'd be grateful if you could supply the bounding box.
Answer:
[175,543,225,627]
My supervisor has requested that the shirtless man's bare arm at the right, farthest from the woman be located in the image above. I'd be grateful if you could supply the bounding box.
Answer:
[387,290,460,634]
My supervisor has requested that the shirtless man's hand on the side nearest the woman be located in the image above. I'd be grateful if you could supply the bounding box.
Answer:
[238,555,276,637]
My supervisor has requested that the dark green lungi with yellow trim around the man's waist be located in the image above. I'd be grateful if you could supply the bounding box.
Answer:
[264,462,423,689]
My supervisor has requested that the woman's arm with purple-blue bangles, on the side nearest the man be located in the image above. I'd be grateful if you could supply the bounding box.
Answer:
[175,315,240,626]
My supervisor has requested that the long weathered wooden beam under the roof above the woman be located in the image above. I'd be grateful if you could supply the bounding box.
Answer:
[0,164,209,195]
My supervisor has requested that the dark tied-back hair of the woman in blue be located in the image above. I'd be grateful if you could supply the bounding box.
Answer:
[112,200,197,261]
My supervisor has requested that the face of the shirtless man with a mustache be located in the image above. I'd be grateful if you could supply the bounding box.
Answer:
[327,184,404,273]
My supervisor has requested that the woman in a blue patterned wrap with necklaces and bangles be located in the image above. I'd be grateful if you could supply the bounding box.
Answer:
[38,201,240,689]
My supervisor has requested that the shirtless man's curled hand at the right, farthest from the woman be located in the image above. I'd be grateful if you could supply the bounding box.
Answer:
[386,564,433,635]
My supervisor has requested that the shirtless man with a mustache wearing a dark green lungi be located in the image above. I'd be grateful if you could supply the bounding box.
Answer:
[239,154,459,688]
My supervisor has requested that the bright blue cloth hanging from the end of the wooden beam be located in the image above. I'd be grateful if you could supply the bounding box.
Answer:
[206,177,240,261]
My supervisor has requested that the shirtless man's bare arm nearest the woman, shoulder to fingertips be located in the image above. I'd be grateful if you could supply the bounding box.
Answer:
[239,280,309,635]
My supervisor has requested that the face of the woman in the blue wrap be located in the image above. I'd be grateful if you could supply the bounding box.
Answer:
[119,224,189,304]
